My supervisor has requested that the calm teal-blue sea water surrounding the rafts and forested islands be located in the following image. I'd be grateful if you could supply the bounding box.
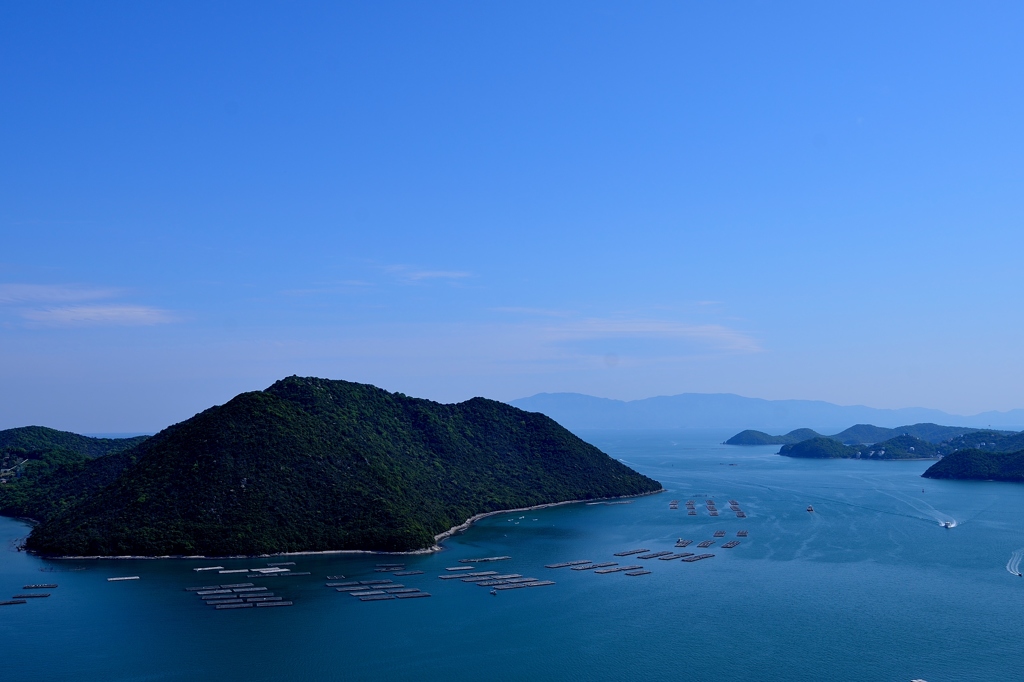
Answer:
[0,431,1024,682]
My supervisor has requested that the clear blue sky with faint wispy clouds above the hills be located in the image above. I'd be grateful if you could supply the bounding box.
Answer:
[0,1,1024,431]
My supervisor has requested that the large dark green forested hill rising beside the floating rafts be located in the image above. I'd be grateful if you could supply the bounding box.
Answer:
[27,377,660,555]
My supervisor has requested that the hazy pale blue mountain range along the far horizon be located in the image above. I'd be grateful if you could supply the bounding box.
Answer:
[510,393,1024,432]
